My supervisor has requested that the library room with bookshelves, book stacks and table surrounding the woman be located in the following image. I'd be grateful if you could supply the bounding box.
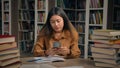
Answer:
[0,0,120,68]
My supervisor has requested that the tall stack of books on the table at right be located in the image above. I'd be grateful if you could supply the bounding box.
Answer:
[91,30,120,67]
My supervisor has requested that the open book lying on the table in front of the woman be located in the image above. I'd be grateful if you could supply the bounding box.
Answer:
[28,56,65,63]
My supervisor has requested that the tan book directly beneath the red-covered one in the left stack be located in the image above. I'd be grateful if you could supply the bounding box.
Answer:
[0,42,17,51]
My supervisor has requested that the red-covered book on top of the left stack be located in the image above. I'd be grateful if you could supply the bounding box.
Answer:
[0,35,15,44]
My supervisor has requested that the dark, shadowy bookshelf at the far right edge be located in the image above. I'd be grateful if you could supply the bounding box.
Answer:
[108,0,120,30]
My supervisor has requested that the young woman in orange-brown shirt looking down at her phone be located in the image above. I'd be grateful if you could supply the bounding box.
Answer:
[34,7,81,58]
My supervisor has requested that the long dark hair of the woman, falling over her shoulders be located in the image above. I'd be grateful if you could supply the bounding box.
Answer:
[41,7,76,37]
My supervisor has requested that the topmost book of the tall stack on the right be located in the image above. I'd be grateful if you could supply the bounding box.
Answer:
[93,29,120,36]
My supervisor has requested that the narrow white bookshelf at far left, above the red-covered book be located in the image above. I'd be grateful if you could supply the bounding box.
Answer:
[2,0,11,35]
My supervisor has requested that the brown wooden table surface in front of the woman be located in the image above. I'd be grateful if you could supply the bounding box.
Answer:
[21,57,118,68]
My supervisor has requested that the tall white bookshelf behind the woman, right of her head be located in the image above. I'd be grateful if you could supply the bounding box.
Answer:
[55,0,108,58]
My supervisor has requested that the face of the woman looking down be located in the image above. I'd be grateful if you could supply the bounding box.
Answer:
[50,15,64,32]
